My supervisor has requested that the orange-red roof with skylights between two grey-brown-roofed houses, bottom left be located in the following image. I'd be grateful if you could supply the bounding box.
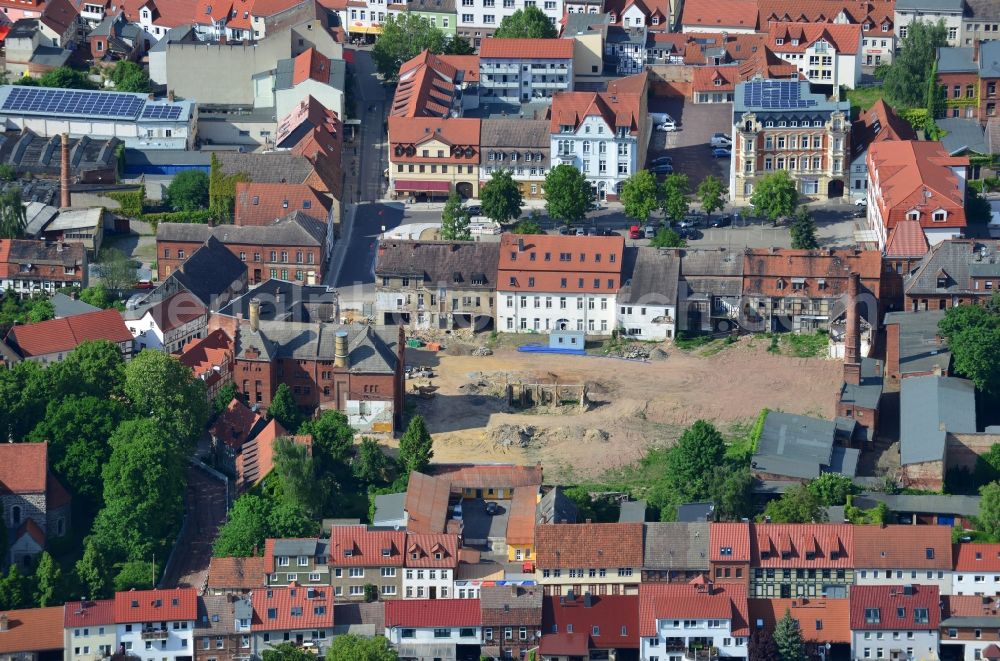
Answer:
[250,583,333,631]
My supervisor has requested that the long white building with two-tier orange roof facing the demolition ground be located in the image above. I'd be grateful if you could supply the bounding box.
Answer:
[497,234,625,335]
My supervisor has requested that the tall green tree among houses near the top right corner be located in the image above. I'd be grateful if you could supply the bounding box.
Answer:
[883,20,948,108]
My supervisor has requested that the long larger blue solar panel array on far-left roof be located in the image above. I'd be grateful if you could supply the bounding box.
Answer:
[0,87,145,119]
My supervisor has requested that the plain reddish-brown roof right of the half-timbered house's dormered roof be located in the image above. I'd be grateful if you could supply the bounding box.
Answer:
[854,526,951,570]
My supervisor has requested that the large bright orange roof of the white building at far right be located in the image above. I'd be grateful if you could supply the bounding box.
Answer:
[868,140,969,229]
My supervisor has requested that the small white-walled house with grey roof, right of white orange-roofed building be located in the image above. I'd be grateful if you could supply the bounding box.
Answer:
[618,248,680,340]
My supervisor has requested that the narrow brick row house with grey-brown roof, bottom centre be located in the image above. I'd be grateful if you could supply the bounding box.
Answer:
[479,585,542,659]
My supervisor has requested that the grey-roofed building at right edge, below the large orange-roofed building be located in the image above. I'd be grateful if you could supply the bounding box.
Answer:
[903,239,1000,311]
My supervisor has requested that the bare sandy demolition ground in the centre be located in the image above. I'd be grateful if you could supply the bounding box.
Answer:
[398,338,841,481]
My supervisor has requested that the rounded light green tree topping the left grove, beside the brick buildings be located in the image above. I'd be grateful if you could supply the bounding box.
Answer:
[124,349,208,448]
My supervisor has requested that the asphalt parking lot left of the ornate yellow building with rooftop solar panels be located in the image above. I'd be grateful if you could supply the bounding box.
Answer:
[648,99,733,191]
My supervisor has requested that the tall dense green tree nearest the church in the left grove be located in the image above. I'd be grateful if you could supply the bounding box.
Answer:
[93,420,187,560]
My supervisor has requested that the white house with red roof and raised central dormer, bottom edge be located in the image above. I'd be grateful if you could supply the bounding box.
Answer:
[639,576,750,661]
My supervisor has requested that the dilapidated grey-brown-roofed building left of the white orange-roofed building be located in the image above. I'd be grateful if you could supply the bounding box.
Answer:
[375,238,500,331]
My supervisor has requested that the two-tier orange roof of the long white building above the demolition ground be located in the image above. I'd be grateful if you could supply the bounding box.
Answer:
[497,234,625,294]
